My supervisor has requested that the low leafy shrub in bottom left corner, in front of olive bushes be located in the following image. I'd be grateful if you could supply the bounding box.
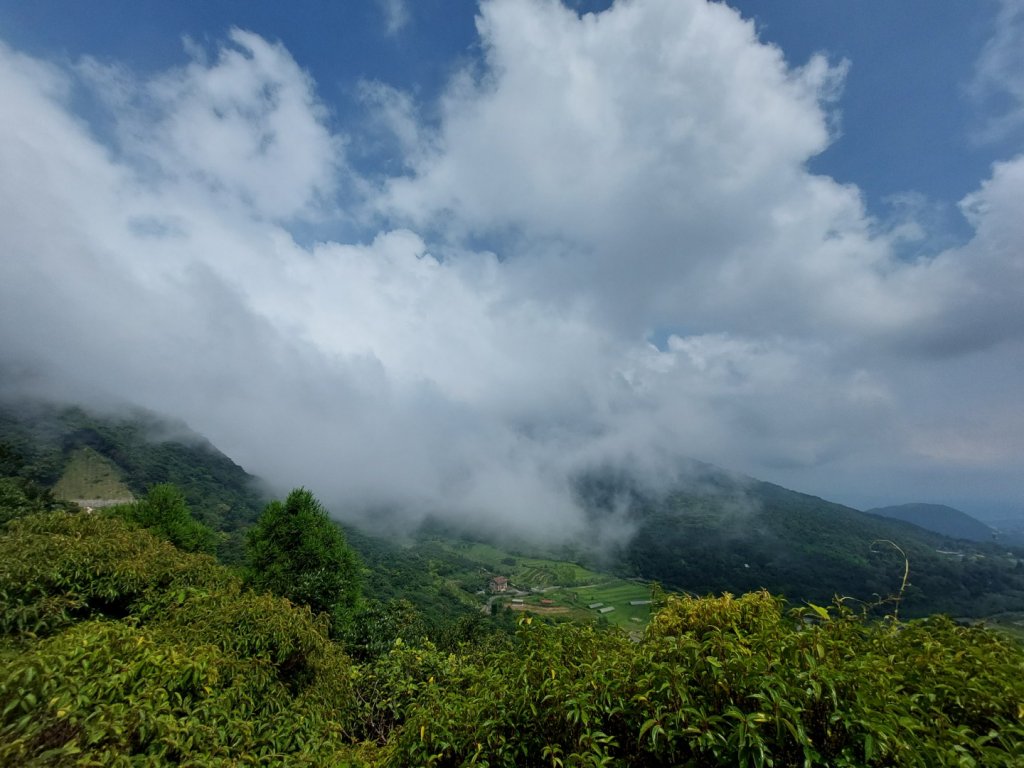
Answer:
[0,622,366,766]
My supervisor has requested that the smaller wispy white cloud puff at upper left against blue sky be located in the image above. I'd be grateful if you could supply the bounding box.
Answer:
[80,29,344,219]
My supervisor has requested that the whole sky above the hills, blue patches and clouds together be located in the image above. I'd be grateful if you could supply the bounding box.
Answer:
[0,0,1024,535]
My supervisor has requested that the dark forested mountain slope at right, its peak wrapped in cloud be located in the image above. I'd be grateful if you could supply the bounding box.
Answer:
[581,465,1024,616]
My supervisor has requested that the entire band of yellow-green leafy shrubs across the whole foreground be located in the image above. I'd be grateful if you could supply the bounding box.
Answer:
[0,505,1024,766]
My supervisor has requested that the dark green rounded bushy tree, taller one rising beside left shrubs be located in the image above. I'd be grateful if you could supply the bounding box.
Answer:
[246,488,360,631]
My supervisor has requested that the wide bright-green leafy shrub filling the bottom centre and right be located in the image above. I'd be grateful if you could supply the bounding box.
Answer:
[390,593,1024,768]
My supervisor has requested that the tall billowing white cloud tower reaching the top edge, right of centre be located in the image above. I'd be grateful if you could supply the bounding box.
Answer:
[374,0,933,348]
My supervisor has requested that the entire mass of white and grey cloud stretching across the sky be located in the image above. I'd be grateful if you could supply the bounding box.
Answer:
[0,0,1024,536]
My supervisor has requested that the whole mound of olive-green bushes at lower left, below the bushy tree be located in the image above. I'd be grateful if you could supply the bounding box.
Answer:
[0,514,376,766]
